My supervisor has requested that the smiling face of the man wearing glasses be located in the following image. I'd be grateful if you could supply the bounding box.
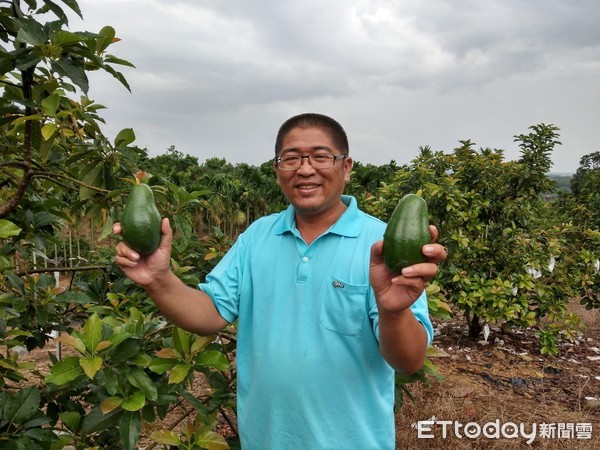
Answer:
[274,128,352,217]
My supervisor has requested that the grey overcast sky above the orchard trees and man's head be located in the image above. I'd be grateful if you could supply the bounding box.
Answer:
[70,0,600,172]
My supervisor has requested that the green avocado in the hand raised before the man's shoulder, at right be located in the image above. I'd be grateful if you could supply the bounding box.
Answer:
[383,194,431,273]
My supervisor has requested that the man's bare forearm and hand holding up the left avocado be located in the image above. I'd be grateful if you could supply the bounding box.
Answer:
[113,219,228,335]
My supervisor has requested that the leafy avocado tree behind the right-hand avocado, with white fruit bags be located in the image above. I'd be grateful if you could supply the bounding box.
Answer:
[362,124,600,354]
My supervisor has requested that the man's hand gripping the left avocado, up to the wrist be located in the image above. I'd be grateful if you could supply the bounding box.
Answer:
[113,218,173,287]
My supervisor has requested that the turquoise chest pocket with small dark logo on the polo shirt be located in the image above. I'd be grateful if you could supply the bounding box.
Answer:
[319,275,369,336]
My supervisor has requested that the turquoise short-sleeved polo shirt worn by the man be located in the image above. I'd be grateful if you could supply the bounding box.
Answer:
[199,196,433,450]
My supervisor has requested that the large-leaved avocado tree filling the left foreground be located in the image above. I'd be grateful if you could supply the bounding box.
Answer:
[0,0,234,449]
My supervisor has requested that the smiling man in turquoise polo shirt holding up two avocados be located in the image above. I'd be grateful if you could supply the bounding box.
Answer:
[115,113,446,450]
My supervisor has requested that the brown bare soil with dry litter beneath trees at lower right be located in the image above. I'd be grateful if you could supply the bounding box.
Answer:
[396,305,600,449]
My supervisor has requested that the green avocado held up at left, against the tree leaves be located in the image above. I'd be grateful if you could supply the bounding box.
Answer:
[121,184,161,255]
